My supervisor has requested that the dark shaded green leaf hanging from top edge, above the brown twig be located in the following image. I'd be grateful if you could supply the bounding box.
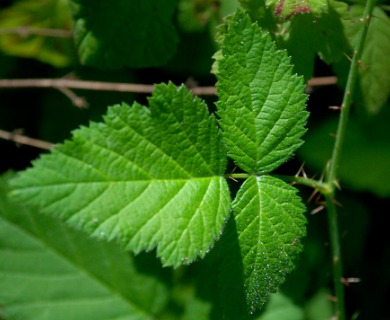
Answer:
[71,0,177,68]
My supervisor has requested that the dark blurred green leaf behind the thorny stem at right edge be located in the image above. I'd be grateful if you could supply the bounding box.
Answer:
[299,106,390,197]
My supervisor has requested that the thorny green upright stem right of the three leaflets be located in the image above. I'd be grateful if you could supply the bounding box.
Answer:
[324,0,375,320]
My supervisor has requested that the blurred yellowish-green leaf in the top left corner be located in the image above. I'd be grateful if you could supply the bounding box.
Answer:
[0,0,76,67]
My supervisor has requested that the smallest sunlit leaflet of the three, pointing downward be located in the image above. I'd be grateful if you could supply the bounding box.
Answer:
[221,176,306,313]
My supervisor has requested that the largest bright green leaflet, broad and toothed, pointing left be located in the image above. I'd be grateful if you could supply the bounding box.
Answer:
[13,84,230,266]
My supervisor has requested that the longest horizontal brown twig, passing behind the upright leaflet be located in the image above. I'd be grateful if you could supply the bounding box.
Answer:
[0,76,337,95]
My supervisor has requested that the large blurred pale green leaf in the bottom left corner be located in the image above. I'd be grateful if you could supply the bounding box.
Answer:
[0,174,169,320]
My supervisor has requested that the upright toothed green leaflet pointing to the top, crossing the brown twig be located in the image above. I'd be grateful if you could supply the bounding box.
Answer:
[217,12,308,174]
